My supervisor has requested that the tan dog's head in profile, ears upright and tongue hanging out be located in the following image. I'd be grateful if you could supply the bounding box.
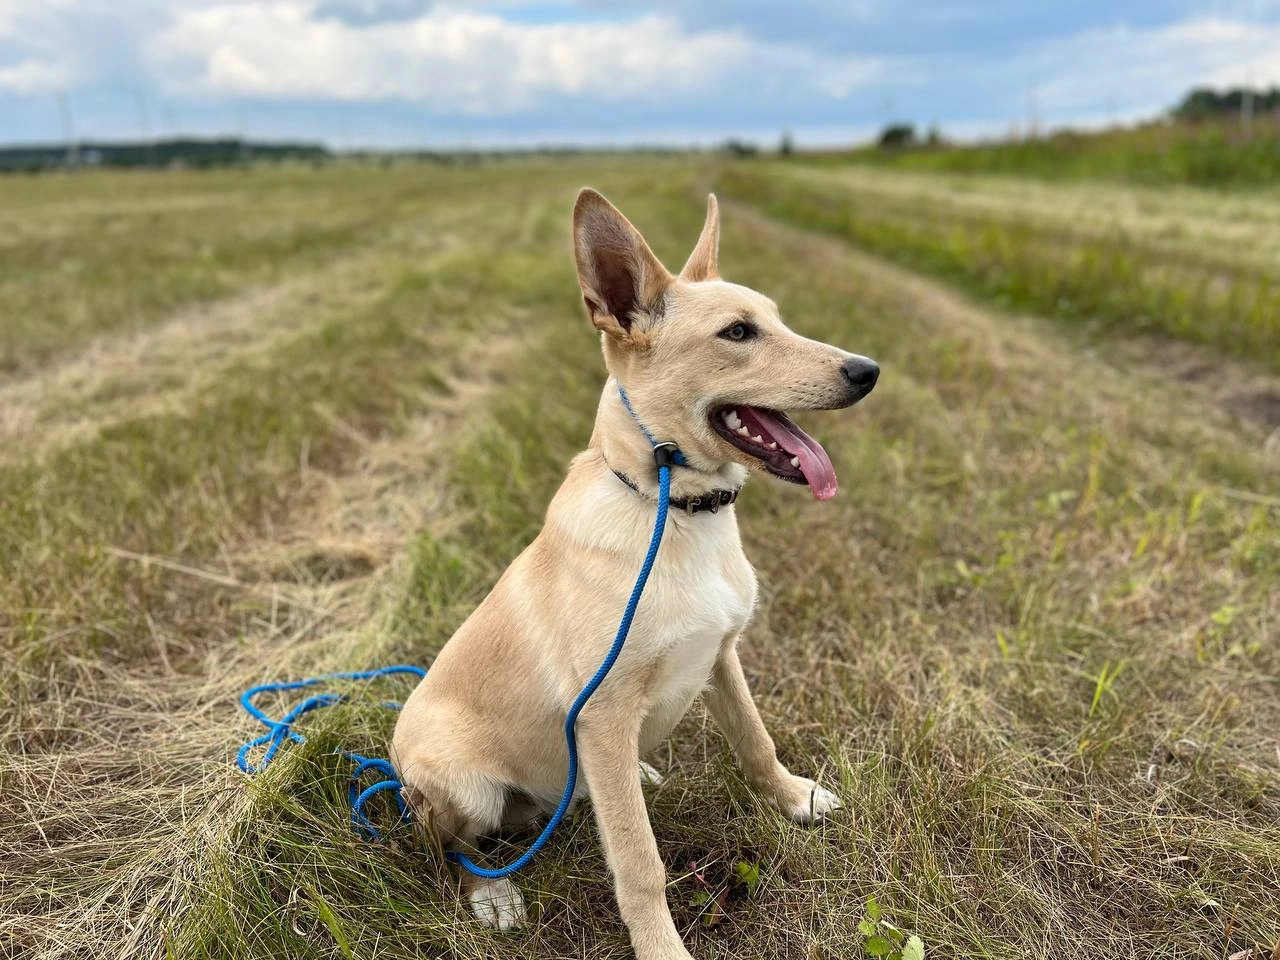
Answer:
[573,189,879,499]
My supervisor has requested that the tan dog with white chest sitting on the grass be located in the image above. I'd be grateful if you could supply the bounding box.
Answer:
[392,189,879,960]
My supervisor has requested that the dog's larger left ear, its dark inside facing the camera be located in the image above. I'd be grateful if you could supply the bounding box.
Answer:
[573,188,673,338]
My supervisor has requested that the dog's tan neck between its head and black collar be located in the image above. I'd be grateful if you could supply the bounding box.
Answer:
[590,378,748,500]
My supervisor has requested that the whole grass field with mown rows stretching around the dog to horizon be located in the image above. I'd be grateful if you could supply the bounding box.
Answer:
[0,157,1280,960]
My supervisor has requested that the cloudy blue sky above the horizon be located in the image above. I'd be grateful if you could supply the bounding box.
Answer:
[0,0,1280,148]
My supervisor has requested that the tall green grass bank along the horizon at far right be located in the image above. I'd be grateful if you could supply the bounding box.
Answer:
[828,116,1280,188]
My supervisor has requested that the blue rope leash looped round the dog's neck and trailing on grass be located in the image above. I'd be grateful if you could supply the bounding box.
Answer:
[236,384,685,879]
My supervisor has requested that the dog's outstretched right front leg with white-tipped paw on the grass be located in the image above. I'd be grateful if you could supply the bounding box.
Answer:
[703,637,840,823]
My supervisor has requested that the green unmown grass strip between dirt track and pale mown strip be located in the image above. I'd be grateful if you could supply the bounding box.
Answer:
[723,164,1280,370]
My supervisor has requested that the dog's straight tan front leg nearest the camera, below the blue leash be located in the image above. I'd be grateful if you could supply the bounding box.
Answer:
[577,704,692,960]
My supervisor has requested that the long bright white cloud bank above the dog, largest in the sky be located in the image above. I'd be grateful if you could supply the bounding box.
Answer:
[147,0,874,114]
